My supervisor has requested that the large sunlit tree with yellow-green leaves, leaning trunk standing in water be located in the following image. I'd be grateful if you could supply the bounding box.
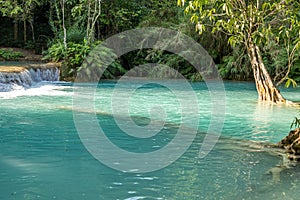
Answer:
[178,0,300,103]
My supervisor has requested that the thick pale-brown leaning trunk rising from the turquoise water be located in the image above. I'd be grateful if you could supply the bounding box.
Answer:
[247,41,286,103]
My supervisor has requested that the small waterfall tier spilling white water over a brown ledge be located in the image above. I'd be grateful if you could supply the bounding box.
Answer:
[0,63,60,92]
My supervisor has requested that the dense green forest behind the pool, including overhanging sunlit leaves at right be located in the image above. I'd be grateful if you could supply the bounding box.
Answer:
[0,0,300,90]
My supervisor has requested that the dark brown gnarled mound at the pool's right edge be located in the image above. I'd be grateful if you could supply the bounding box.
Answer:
[278,128,300,161]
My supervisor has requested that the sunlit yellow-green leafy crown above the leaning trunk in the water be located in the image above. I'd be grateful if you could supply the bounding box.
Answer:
[178,0,300,46]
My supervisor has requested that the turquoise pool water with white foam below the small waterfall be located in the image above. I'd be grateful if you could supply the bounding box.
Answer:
[0,82,300,200]
